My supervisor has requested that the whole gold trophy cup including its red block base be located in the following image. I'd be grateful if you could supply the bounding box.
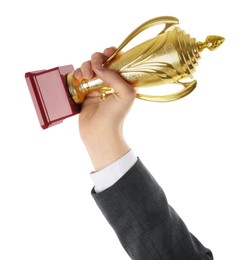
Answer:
[25,16,224,128]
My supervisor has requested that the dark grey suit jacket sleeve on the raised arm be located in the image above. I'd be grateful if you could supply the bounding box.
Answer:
[92,159,213,260]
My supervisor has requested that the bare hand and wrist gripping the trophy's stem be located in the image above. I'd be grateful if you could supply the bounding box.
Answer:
[74,48,136,171]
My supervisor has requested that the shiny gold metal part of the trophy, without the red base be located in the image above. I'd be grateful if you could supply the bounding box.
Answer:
[67,16,224,103]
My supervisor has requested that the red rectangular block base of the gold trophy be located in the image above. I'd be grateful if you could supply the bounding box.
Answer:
[25,65,81,129]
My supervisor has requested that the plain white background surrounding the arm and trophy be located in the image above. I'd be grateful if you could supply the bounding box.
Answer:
[0,0,249,260]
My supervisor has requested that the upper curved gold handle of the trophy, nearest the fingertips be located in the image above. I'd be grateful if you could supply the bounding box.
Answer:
[104,16,179,65]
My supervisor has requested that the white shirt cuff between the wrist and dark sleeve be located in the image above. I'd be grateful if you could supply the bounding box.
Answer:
[91,150,137,193]
